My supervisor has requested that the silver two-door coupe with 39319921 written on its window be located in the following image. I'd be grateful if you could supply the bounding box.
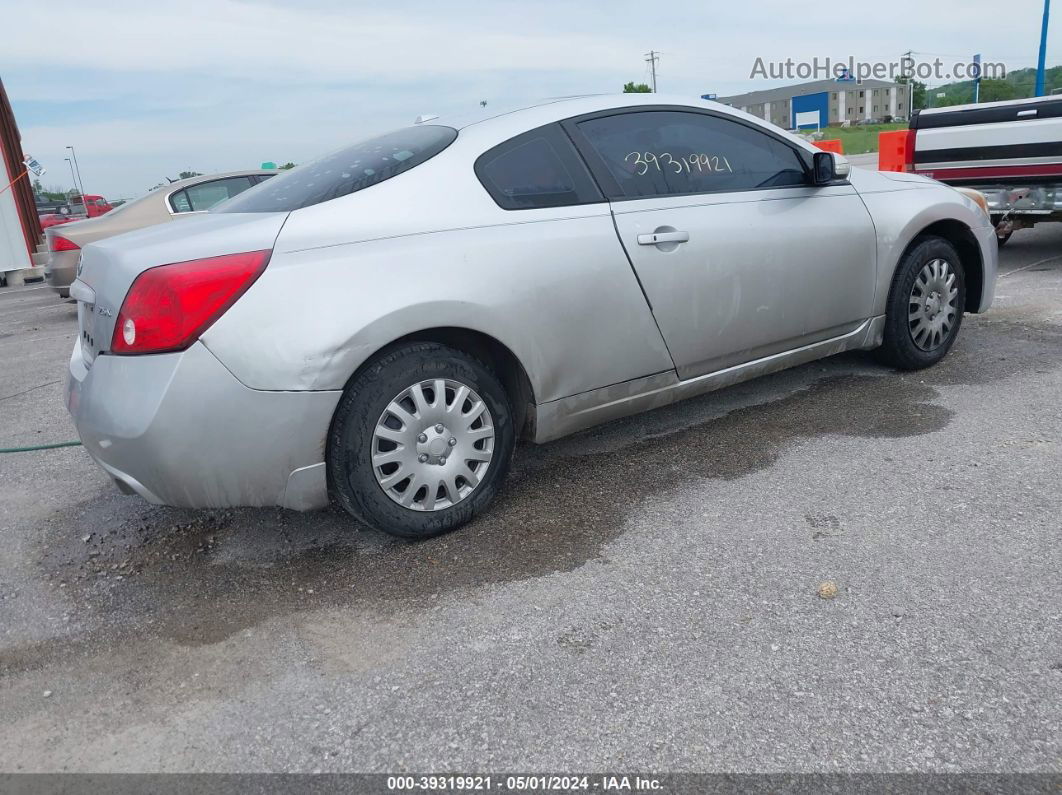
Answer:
[67,94,997,538]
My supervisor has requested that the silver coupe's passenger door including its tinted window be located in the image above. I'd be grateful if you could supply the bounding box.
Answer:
[566,107,876,379]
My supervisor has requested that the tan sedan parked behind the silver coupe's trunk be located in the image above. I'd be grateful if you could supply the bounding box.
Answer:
[45,169,277,298]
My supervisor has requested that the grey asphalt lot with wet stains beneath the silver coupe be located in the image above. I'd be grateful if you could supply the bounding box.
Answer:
[0,225,1062,773]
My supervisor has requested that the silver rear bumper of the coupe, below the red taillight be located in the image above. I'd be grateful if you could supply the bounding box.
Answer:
[66,343,342,511]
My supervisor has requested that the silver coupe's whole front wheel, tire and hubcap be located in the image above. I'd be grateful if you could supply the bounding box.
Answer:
[878,237,966,369]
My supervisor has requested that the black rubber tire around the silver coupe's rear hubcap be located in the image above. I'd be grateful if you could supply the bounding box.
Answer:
[327,343,515,539]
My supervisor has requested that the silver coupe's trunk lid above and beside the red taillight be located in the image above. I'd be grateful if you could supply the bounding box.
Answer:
[70,212,288,366]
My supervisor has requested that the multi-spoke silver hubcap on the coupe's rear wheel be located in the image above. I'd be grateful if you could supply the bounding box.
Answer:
[372,378,494,511]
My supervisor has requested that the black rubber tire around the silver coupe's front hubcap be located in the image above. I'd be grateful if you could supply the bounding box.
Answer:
[877,236,966,369]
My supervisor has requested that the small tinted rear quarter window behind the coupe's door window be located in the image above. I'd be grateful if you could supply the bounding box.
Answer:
[476,125,603,210]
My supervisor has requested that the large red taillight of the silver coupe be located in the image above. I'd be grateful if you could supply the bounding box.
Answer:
[110,250,271,353]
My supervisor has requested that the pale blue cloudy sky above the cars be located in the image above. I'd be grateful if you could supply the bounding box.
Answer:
[0,0,1062,198]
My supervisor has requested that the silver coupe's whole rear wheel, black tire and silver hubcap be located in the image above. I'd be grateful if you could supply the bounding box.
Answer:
[328,343,515,538]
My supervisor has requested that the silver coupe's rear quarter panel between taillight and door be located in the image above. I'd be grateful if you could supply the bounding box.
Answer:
[203,214,673,401]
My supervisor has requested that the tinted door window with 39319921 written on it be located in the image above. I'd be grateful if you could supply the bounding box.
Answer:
[578,110,807,198]
